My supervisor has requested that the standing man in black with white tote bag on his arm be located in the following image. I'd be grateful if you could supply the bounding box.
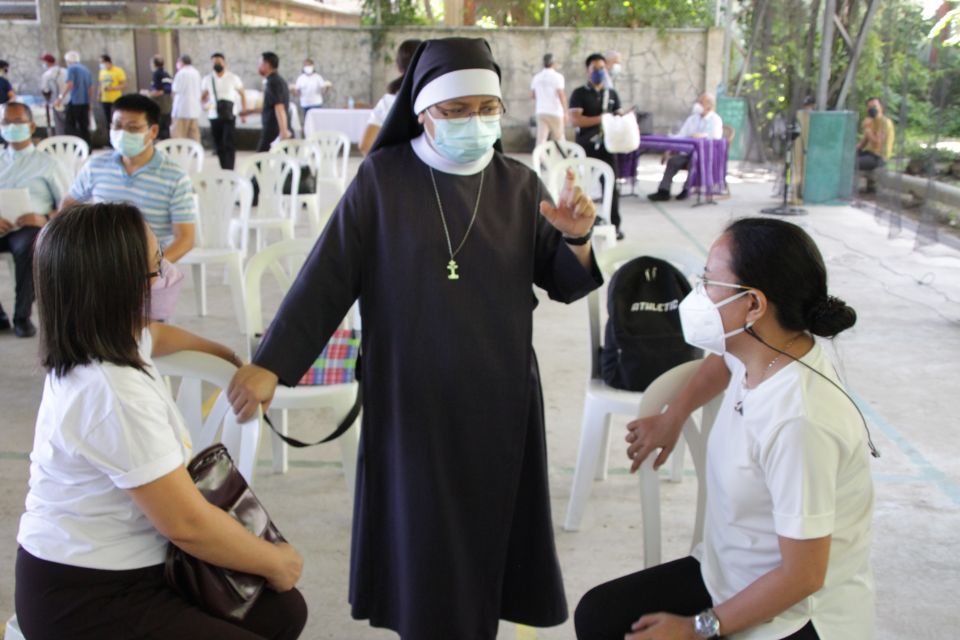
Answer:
[569,53,623,240]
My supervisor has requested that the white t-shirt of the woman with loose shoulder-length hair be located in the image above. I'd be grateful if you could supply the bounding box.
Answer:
[17,331,192,571]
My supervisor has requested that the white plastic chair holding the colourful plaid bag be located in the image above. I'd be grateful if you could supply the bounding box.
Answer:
[244,239,360,496]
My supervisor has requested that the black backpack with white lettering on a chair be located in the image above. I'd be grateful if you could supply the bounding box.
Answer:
[600,256,703,391]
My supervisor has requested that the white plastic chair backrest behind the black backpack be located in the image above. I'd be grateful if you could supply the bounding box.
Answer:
[587,242,705,378]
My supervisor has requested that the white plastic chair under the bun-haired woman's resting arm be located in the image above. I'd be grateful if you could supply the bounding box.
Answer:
[637,360,723,567]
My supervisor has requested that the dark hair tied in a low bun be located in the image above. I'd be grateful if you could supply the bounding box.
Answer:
[725,218,857,338]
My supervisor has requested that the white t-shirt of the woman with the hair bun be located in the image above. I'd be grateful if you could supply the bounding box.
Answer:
[694,345,874,640]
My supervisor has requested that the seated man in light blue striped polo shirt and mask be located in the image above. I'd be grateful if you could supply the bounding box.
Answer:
[63,94,196,262]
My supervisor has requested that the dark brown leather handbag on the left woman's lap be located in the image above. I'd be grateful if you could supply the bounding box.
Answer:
[164,443,286,620]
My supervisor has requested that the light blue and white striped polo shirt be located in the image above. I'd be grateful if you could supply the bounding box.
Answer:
[69,149,196,247]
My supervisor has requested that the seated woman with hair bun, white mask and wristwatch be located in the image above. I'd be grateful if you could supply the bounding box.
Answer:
[576,218,876,640]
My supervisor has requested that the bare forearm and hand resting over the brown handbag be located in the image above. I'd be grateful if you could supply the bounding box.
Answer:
[128,466,303,591]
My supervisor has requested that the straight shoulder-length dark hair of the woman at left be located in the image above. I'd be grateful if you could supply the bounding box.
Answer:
[33,203,150,377]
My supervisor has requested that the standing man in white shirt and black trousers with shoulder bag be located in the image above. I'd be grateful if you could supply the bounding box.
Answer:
[200,53,247,170]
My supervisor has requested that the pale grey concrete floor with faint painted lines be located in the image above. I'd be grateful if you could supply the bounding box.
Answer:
[0,151,960,640]
